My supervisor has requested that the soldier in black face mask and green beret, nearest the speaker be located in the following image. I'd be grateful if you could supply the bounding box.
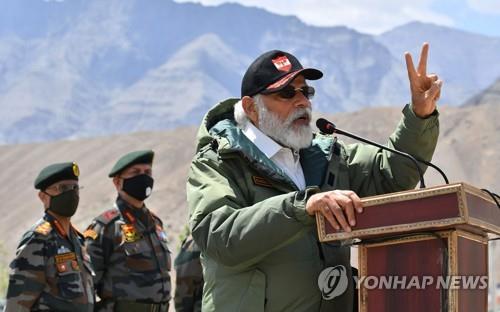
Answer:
[84,150,171,312]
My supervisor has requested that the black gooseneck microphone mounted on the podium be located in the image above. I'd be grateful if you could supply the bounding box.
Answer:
[316,118,449,188]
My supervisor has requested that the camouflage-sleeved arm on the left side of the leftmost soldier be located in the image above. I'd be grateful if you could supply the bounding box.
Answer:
[5,233,47,312]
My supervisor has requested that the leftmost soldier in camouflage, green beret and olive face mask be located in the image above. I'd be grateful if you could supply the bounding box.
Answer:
[4,162,94,312]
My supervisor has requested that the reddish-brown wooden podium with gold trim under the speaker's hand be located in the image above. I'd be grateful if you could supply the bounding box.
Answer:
[317,183,500,312]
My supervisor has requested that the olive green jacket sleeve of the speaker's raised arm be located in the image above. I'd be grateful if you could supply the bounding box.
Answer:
[346,105,439,196]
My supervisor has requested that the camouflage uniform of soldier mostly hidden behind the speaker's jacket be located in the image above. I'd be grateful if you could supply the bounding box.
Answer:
[174,234,203,312]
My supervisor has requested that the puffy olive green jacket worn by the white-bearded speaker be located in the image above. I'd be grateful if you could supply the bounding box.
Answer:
[187,99,439,312]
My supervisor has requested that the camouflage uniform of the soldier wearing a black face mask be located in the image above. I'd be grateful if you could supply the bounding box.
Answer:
[84,197,171,311]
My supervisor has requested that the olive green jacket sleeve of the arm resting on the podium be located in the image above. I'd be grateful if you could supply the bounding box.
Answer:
[187,155,317,267]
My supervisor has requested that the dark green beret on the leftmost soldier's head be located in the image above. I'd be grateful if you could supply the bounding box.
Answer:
[34,162,80,190]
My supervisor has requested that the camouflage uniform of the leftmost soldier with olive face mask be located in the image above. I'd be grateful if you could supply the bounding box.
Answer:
[4,213,94,312]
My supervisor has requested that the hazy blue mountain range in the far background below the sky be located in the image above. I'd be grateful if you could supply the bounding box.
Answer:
[0,0,500,144]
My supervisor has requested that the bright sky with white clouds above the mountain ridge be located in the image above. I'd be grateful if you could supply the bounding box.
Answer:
[175,0,500,37]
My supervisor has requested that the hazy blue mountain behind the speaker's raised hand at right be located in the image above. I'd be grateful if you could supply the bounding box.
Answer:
[377,22,500,105]
